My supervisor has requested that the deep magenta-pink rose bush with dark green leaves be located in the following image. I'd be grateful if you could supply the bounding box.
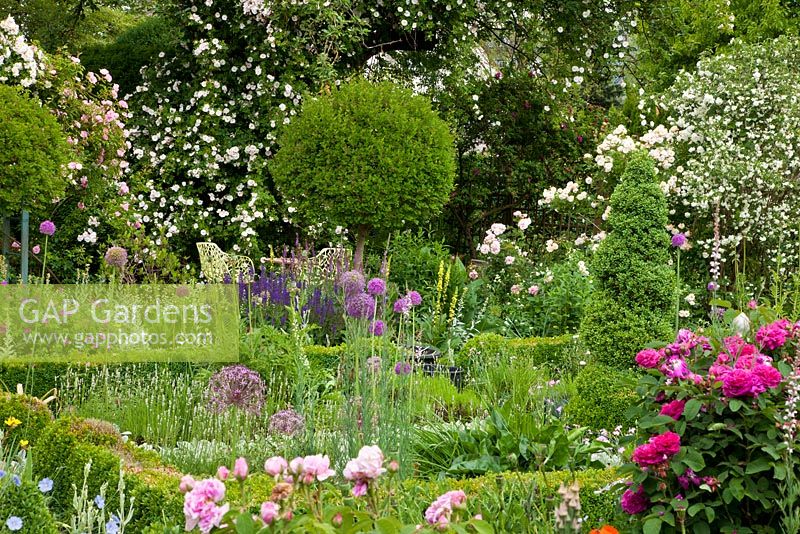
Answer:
[620,316,800,532]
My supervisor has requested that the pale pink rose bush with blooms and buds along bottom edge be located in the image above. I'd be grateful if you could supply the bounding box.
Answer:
[179,445,493,534]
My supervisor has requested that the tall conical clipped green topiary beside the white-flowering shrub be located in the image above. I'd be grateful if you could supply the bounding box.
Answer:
[580,153,675,369]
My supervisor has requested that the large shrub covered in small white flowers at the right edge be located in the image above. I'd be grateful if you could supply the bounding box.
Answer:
[580,38,800,276]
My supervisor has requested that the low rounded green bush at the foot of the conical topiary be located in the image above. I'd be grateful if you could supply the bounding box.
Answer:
[564,364,638,430]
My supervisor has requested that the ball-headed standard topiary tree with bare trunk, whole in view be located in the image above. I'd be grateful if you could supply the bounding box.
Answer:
[270,79,455,267]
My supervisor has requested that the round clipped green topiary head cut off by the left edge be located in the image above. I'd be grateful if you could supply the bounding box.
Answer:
[0,85,70,213]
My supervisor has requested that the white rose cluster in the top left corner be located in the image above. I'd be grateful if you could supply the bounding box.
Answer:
[0,16,44,87]
